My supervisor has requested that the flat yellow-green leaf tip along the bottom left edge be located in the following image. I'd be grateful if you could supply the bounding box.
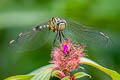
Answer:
[4,75,34,80]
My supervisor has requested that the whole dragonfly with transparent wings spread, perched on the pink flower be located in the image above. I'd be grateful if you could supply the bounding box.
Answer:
[9,17,111,49]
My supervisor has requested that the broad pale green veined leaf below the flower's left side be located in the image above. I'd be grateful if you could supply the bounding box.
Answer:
[31,67,53,80]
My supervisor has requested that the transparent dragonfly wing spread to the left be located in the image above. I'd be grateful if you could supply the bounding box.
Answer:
[10,23,50,51]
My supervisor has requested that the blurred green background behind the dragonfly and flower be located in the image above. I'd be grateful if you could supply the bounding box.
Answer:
[0,0,120,80]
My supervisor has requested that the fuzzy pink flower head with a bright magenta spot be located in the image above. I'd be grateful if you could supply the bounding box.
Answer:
[51,38,85,76]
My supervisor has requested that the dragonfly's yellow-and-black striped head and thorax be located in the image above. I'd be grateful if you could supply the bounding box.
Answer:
[48,17,66,32]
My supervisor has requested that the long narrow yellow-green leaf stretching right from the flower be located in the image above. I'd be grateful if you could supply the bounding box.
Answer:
[80,57,120,80]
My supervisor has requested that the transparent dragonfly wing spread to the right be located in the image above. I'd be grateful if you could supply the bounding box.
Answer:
[64,20,112,47]
